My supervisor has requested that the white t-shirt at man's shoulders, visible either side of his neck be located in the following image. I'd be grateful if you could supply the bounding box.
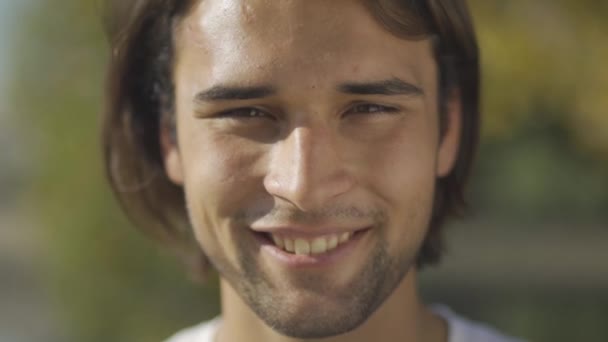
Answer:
[165,305,523,342]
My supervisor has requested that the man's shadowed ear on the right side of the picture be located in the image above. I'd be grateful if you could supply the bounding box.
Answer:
[437,89,462,178]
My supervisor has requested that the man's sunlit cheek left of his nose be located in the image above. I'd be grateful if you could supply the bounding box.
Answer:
[181,130,263,256]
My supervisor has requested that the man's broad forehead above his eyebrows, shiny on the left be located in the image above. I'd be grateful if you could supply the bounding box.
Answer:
[176,0,435,88]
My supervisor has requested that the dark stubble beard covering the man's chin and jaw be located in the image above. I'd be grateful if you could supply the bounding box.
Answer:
[224,231,415,339]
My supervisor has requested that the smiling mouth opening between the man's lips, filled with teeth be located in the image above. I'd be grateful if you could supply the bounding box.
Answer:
[259,229,367,255]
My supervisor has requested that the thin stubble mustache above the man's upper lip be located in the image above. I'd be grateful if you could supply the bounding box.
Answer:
[233,206,387,224]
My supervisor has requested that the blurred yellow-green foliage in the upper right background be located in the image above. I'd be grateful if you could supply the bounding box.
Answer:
[472,0,608,158]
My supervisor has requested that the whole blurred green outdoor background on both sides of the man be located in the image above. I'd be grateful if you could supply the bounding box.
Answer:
[0,0,608,342]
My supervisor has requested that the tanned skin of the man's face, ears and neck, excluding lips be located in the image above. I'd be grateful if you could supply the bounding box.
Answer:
[161,0,460,342]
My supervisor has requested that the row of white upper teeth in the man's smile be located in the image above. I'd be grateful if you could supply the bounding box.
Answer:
[271,232,353,255]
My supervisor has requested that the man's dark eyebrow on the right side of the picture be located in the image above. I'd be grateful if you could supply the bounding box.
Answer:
[338,77,424,96]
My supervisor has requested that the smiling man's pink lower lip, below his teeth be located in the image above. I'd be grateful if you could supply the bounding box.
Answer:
[253,228,370,268]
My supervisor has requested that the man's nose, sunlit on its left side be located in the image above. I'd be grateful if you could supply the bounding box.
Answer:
[264,126,355,211]
